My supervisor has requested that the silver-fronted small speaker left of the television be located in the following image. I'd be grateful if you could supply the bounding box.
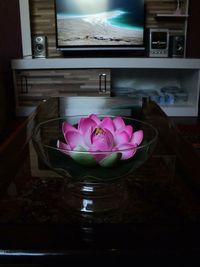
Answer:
[32,35,47,58]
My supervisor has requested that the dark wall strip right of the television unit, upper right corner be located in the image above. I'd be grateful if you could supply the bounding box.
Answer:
[187,0,200,58]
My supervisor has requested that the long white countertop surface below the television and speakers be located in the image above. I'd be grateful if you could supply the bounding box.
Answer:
[11,57,200,70]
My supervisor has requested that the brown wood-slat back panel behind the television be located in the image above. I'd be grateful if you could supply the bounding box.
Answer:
[29,0,186,57]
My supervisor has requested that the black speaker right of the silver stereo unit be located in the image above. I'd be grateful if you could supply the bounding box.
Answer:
[169,35,185,57]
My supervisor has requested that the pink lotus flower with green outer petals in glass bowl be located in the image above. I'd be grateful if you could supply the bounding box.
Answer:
[57,114,143,167]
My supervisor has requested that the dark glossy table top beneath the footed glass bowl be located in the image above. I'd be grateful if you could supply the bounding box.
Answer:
[0,97,200,224]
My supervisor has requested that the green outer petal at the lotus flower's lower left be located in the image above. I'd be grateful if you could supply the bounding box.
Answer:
[70,145,97,166]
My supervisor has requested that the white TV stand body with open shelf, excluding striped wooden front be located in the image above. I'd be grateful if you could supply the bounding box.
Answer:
[12,58,200,116]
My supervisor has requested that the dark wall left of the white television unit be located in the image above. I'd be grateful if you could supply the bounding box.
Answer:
[0,0,22,123]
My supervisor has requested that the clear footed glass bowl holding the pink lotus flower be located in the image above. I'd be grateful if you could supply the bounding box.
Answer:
[32,115,158,214]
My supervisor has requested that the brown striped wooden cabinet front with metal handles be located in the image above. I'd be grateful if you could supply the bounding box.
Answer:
[17,69,110,106]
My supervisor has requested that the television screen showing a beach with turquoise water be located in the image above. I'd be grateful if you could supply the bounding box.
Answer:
[55,0,145,50]
